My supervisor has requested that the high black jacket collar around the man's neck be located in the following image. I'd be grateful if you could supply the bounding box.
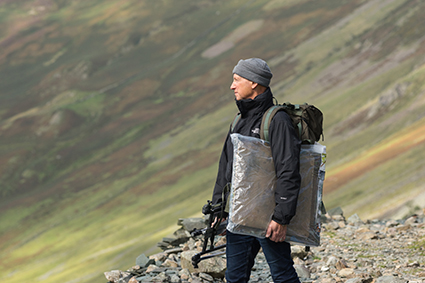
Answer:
[236,88,273,118]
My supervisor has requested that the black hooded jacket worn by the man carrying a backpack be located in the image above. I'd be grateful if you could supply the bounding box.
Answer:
[212,88,301,224]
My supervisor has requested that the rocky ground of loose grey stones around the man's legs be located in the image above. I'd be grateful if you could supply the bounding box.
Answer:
[105,210,425,283]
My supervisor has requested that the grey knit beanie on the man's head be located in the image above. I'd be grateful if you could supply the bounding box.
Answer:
[233,58,273,87]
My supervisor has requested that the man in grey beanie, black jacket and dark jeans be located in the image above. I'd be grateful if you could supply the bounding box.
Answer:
[213,58,301,283]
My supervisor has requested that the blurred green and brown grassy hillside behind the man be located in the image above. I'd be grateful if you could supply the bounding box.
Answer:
[0,0,425,283]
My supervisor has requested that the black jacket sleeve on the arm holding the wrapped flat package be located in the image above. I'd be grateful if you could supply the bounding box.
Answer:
[270,111,301,225]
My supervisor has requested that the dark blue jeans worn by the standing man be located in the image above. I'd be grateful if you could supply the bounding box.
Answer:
[226,231,300,283]
